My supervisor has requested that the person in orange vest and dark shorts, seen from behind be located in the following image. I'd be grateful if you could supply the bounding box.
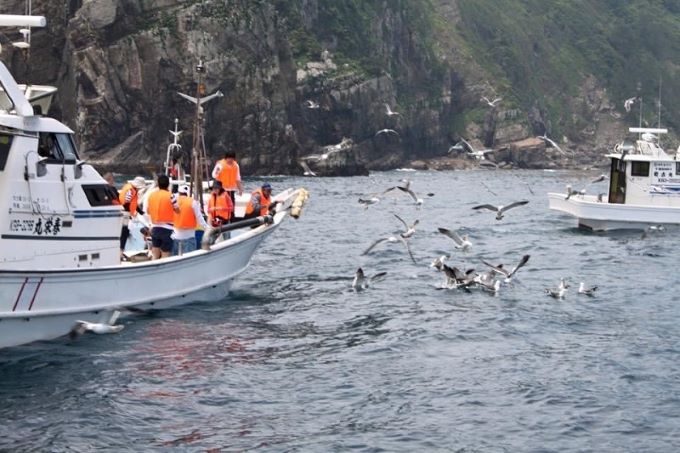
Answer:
[146,175,179,260]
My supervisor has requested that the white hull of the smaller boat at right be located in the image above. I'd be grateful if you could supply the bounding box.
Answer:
[548,193,680,231]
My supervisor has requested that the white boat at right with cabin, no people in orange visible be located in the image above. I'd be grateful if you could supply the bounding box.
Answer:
[548,127,680,231]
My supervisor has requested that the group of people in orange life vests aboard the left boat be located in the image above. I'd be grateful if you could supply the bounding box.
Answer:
[106,152,272,259]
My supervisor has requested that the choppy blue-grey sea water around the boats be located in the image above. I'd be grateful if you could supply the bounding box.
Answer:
[0,171,680,452]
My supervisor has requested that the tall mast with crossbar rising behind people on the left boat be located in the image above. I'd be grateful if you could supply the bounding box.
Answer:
[178,59,224,209]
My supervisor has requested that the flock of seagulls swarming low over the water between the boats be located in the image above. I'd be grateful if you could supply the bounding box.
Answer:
[352,177,604,299]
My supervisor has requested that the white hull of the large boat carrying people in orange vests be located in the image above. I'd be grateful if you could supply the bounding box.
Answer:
[0,222,279,348]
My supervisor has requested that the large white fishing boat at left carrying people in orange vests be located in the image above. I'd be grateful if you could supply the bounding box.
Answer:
[0,16,306,348]
